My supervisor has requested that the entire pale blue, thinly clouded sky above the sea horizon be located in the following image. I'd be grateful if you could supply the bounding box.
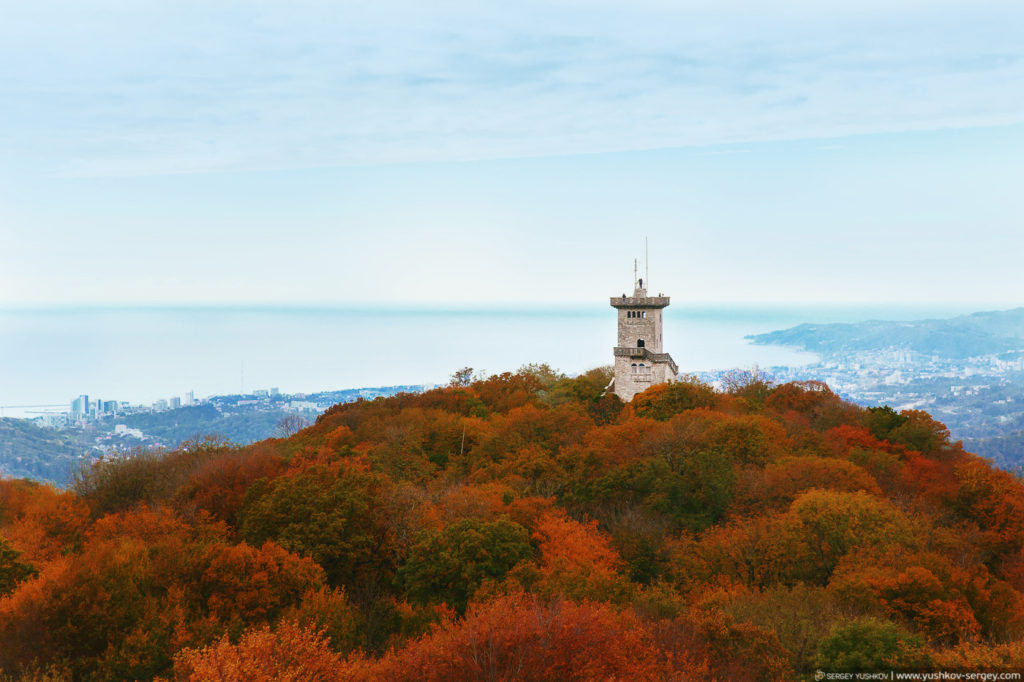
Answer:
[0,0,1024,305]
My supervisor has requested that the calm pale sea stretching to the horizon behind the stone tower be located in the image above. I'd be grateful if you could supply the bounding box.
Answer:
[0,303,980,417]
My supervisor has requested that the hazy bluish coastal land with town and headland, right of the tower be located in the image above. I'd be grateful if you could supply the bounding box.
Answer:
[746,307,1024,470]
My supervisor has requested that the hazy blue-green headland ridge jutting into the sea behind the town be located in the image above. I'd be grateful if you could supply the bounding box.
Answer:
[746,307,1024,359]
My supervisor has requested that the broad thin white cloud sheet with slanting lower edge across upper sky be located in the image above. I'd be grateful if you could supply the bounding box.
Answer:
[0,2,1024,176]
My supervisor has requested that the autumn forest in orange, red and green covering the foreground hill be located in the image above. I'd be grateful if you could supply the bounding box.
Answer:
[0,366,1024,681]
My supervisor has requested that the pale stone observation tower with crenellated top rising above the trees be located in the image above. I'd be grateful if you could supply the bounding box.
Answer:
[611,265,679,402]
